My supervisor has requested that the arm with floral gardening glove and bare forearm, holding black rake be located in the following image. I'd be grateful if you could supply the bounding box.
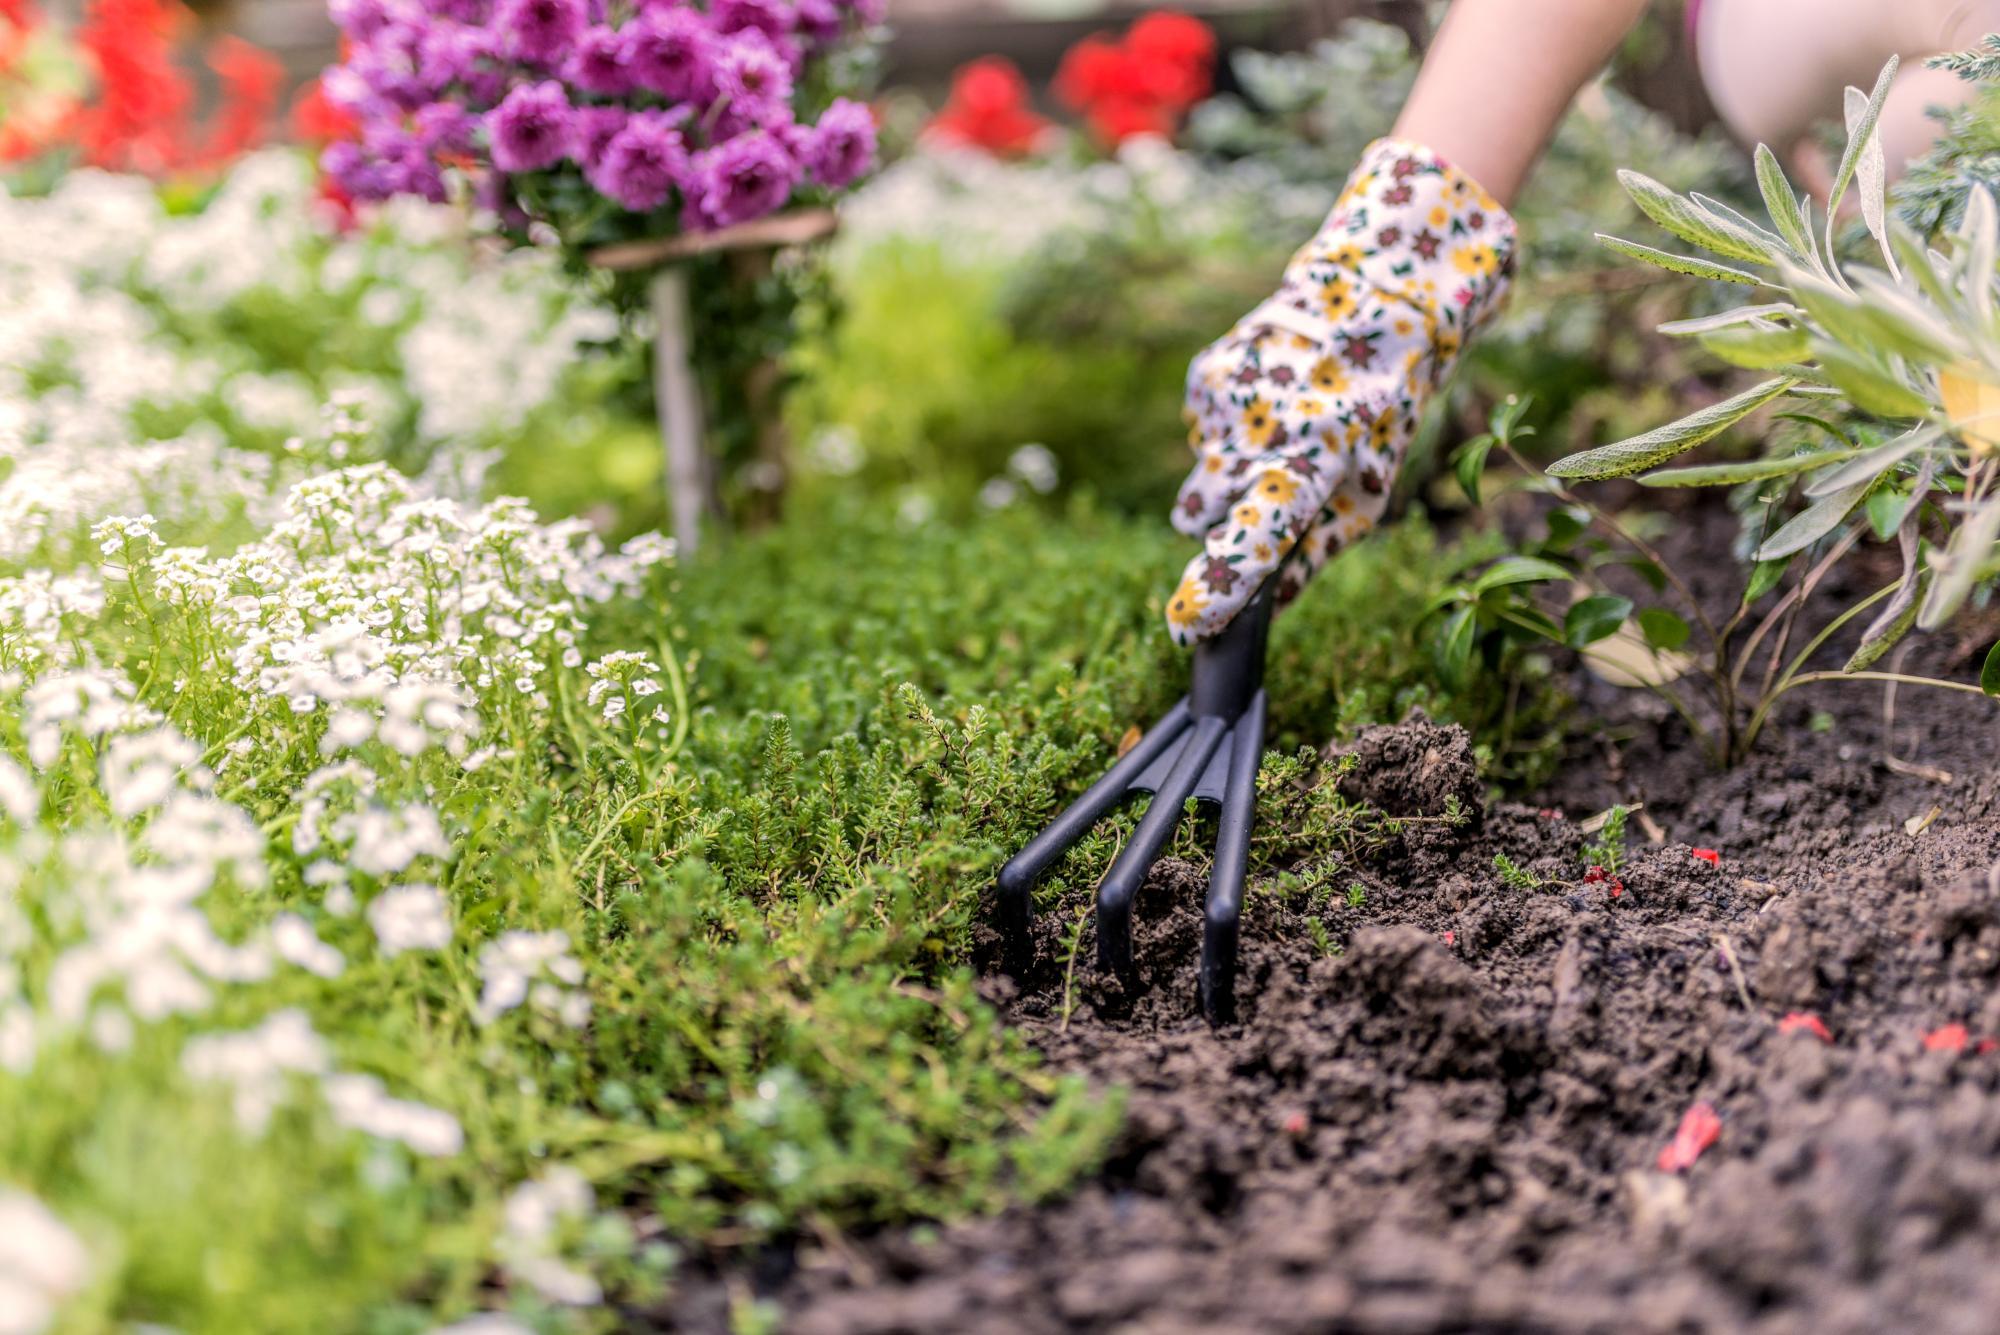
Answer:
[1166,0,1644,644]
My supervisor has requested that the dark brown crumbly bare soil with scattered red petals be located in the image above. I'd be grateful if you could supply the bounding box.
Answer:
[680,505,2000,1335]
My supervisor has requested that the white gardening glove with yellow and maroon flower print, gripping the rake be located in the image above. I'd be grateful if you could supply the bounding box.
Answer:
[1166,140,1514,646]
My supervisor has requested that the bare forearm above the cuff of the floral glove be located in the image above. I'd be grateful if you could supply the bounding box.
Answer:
[1394,0,1646,204]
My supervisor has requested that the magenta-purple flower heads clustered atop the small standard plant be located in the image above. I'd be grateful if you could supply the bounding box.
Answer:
[324,0,884,232]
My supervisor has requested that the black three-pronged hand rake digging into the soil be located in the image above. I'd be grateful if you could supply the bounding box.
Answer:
[1000,580,1276,1023]
